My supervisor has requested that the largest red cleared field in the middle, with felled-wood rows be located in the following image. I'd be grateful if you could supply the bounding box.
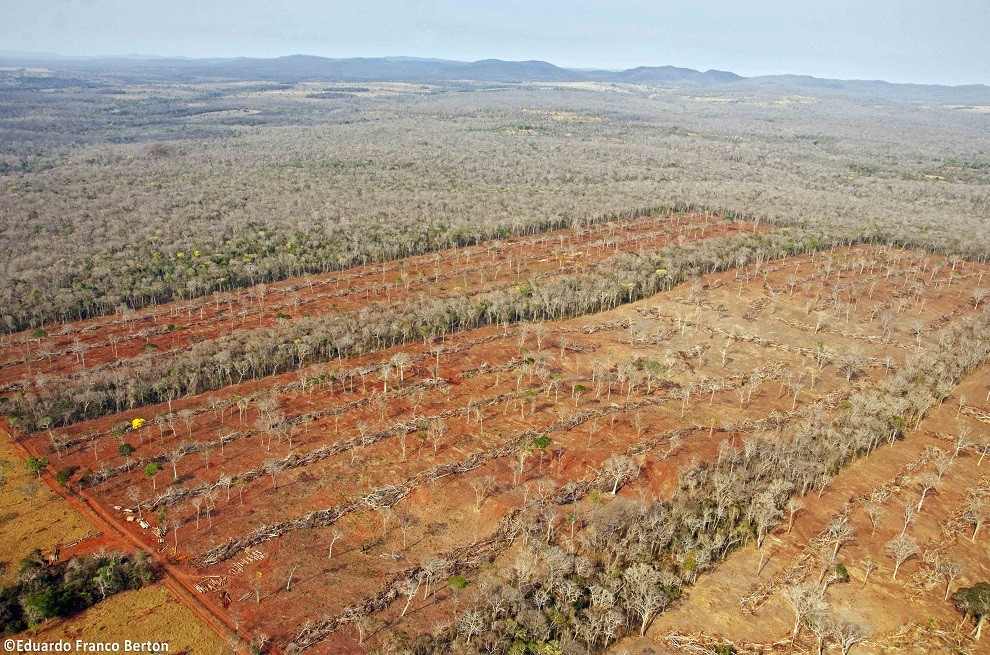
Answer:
[9,241,985,653]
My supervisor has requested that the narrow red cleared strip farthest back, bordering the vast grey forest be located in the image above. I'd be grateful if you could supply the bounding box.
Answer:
[0,214,757,390]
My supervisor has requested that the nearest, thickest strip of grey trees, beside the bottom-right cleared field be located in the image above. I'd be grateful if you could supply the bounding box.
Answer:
[396,317,990,655]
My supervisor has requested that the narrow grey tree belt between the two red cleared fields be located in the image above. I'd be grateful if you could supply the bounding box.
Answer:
[5,223,857,432]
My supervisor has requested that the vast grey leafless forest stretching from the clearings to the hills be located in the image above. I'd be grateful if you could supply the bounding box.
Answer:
[0,70,990,330]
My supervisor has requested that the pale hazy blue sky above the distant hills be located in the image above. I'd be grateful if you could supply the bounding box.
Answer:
[0,0,990,84]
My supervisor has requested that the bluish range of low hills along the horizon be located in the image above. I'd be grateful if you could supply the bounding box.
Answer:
[0,51,990,104]
